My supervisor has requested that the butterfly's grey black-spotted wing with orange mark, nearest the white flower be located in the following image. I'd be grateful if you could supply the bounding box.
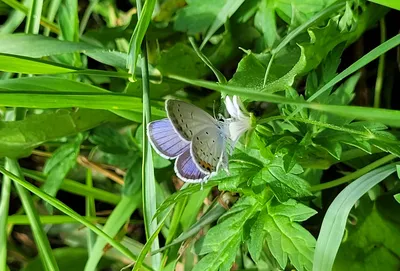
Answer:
[190,126,227,174]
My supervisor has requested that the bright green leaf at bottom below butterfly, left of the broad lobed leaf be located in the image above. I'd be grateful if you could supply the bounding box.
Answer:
[193,197,259,271]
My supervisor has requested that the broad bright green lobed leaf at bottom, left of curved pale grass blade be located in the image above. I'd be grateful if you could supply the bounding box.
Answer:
[249,200,316,270]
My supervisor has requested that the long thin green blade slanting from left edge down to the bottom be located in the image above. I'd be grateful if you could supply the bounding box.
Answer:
[0,167,141,266]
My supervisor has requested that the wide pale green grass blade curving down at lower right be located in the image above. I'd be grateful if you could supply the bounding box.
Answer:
[313,164,396,271]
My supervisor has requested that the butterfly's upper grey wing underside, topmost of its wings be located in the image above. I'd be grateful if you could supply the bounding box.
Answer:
[165,99,217,141]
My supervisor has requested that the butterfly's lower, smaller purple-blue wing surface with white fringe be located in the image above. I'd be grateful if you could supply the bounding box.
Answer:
[175,148,209,183]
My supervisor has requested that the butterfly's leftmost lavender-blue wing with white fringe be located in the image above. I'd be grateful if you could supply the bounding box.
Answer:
[147,118,190,159]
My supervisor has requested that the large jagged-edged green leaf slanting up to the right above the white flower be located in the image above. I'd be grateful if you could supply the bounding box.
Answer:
[229,4,386,93]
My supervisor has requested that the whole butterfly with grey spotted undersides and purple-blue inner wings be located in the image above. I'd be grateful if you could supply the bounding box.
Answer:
[147,99,229,183]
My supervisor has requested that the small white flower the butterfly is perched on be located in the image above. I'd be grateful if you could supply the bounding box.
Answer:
[225,95,253,144]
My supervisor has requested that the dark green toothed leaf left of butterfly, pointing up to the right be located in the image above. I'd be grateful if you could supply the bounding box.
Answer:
[42,134,84,199]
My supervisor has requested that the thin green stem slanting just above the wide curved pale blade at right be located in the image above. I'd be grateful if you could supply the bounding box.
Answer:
[310,154,397,192]
